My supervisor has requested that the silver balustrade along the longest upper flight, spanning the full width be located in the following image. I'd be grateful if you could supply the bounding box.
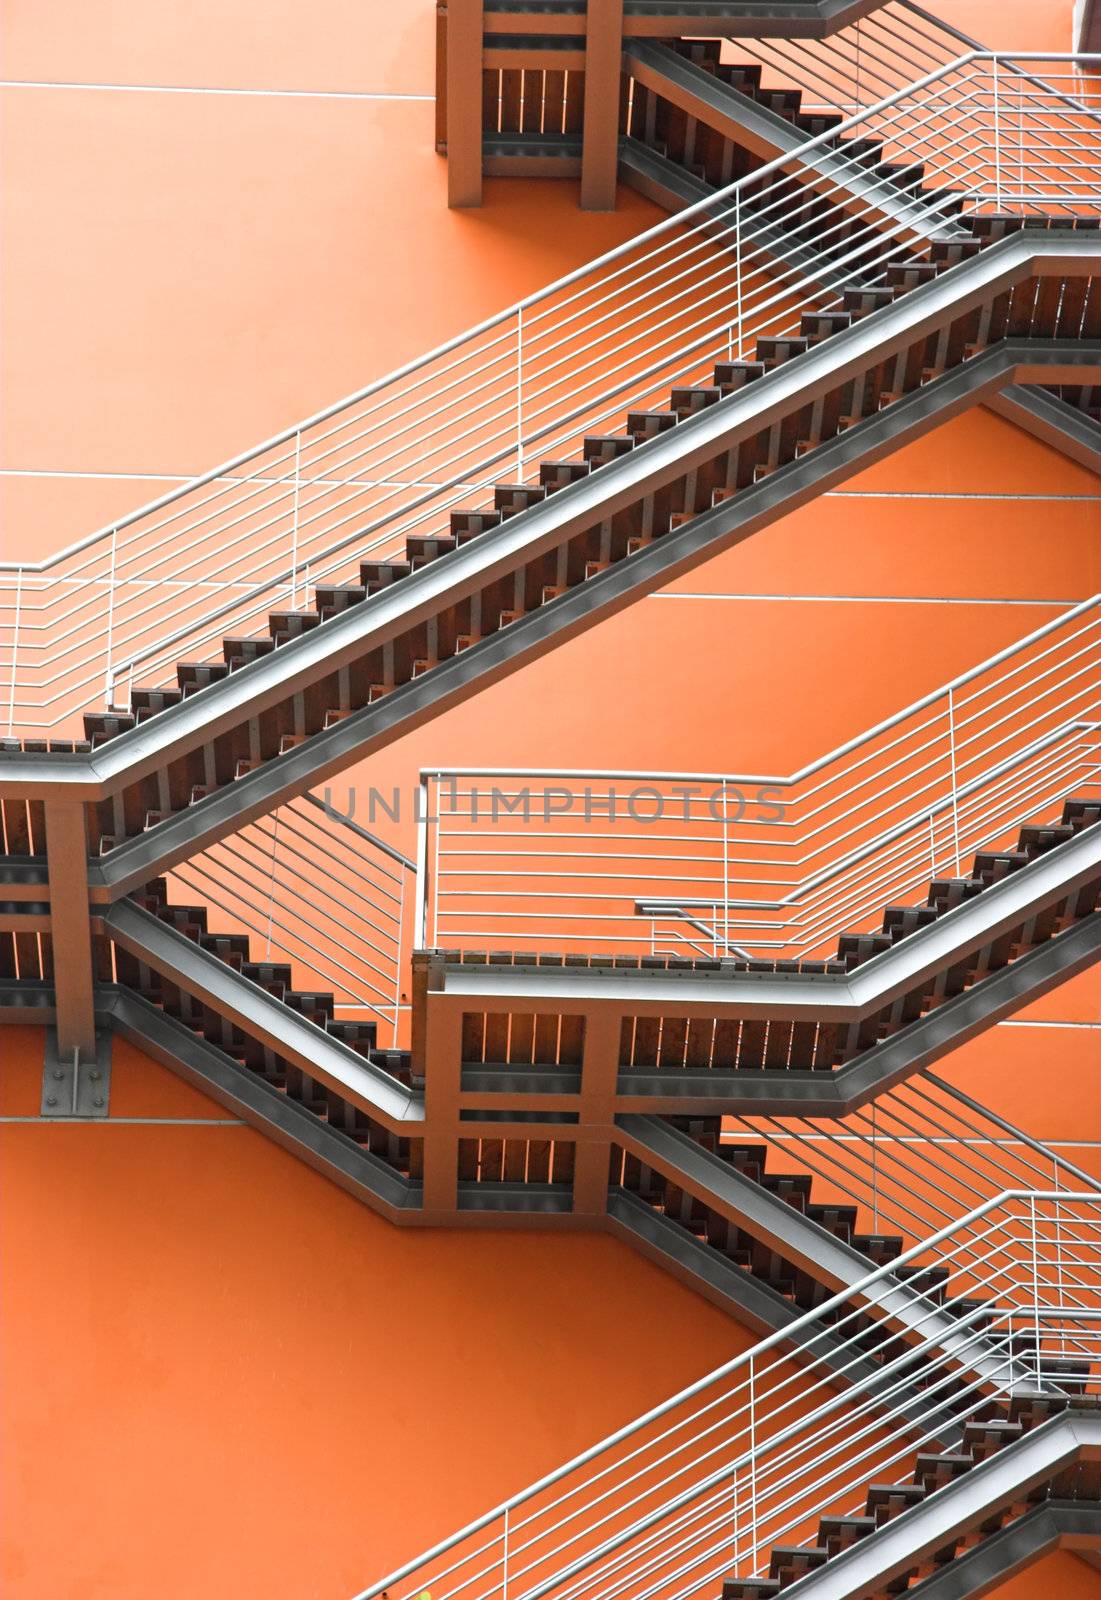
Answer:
[0,51,1101,736]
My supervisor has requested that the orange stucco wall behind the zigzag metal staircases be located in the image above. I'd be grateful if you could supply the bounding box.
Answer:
[0,0,1101,1600]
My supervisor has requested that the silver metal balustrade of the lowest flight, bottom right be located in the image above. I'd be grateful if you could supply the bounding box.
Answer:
[357,1192,1101,1600]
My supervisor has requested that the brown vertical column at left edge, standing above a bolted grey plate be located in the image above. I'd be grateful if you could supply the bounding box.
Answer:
[46,800,96,1061]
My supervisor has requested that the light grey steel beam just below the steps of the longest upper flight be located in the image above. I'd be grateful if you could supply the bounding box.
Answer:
[0,230,1101,812]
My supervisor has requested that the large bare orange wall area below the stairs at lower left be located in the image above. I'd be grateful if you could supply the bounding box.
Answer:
[0,1029,752,1600]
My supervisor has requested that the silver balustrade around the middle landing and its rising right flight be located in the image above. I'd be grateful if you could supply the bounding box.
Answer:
[416,595,1101,958]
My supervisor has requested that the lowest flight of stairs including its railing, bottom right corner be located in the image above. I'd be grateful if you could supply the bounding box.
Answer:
[357,1194,1101,1600]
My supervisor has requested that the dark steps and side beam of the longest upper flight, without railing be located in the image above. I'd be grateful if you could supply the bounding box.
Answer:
[6,218,1101,889]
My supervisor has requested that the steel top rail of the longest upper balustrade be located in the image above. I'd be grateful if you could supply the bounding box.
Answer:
[0,48,1101,585]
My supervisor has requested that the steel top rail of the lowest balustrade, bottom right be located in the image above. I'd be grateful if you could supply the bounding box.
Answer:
[354,1189,1101,1600]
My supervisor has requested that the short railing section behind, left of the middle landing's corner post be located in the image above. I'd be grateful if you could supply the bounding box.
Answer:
[168,794,416,1045]
